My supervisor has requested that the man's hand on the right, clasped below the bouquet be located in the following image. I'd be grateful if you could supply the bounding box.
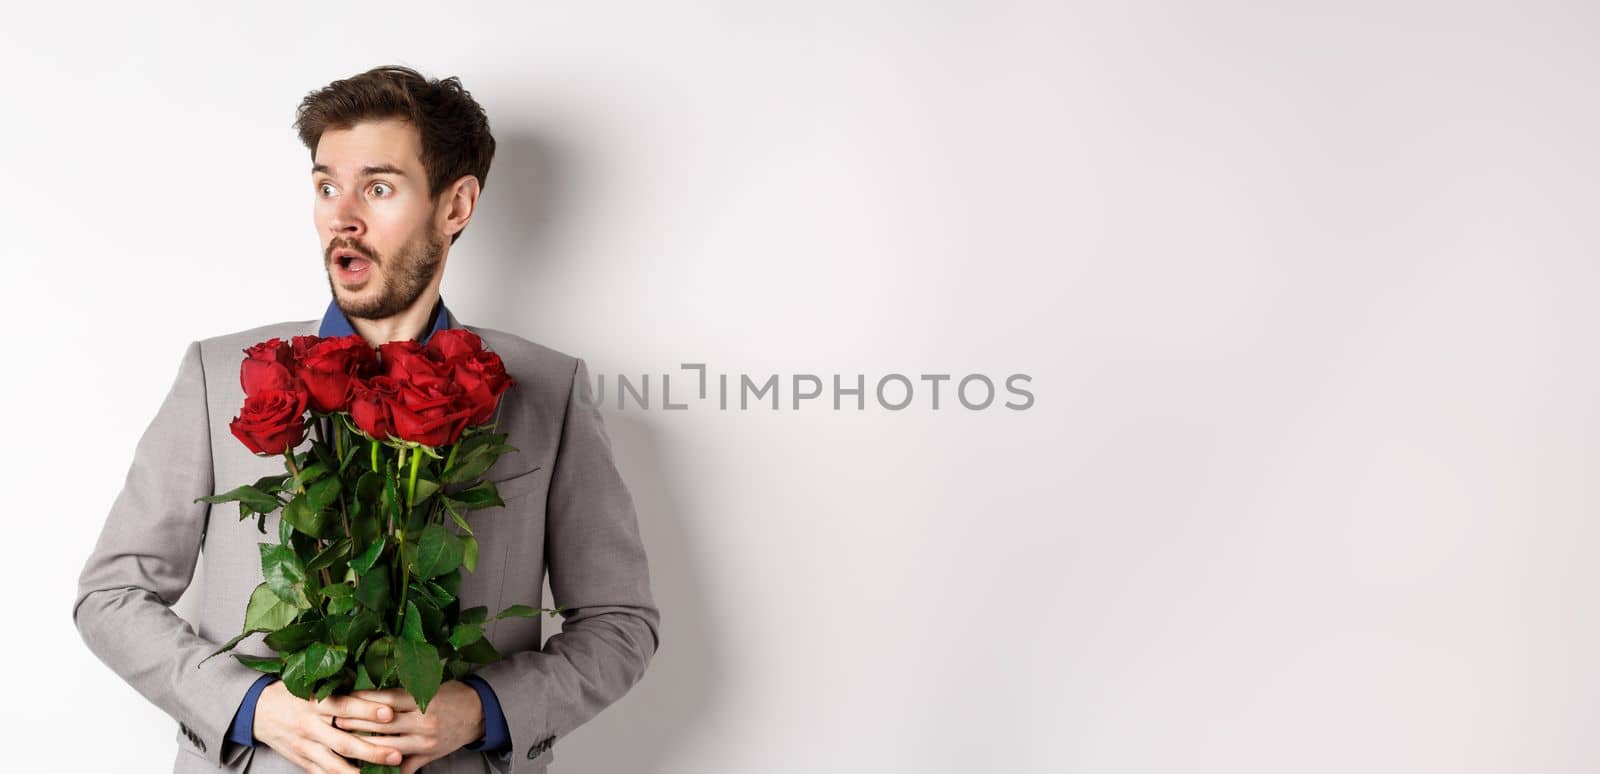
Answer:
[339,680,483,774]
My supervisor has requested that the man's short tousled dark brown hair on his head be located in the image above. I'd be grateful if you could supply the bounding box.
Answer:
[294,66,494,245]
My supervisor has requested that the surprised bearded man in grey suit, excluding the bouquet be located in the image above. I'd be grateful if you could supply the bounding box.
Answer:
[72,67,661,774]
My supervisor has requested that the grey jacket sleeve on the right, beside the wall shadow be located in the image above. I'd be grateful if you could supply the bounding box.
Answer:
[475,358,661,772]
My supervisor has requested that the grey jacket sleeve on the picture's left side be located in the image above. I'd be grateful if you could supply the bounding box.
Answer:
[72,342,261,771]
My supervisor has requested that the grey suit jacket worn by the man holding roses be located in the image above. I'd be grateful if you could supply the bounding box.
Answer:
[72,310,661,774]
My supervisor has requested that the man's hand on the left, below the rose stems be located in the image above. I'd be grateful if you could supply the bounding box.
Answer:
[254,680,406,774]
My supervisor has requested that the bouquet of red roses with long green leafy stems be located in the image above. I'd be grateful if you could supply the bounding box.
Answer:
[200,329,560,726]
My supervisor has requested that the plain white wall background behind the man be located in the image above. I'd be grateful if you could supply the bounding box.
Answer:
[0,0,1600,774]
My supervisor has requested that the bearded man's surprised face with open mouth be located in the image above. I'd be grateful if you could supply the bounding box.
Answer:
[310,120,446,320]
